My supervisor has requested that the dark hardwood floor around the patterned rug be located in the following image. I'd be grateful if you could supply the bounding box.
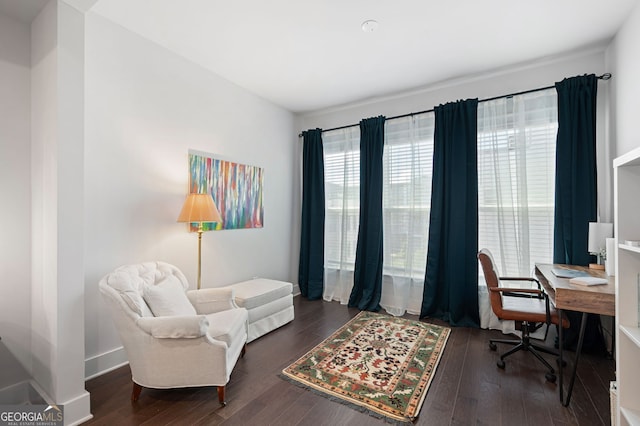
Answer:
[86,296,614,426]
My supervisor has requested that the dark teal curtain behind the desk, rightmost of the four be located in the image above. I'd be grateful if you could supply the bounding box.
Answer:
[553,74,598,265]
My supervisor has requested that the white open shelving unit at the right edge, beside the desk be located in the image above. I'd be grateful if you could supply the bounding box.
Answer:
[613,148,640,425]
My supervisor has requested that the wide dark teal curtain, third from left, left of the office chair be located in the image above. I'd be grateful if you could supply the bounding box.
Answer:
[420,99,480,327]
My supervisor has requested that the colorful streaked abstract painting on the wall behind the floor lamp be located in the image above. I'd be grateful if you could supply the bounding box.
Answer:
[189,151,264,231]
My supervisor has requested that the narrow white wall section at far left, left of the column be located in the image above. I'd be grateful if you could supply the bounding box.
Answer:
[0,14,31,371]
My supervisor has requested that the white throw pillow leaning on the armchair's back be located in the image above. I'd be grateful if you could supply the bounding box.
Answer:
[143,275,196,317]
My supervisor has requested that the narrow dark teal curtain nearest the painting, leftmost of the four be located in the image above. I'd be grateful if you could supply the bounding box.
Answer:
[298,129,324,300]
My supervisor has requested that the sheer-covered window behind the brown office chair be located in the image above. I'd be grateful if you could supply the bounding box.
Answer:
[478,89,558,276]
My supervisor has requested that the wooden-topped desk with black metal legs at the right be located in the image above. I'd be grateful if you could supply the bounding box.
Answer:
[534,263,616,407]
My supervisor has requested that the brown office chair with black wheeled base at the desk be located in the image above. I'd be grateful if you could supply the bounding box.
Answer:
[478,249,569,382]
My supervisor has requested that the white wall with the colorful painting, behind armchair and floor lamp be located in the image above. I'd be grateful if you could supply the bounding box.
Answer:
[79,13,297,376]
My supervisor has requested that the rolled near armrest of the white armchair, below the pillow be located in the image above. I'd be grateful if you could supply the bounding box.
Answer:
[137,315,209,339]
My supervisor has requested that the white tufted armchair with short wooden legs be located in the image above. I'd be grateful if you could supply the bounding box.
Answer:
[99,262,248,405]
